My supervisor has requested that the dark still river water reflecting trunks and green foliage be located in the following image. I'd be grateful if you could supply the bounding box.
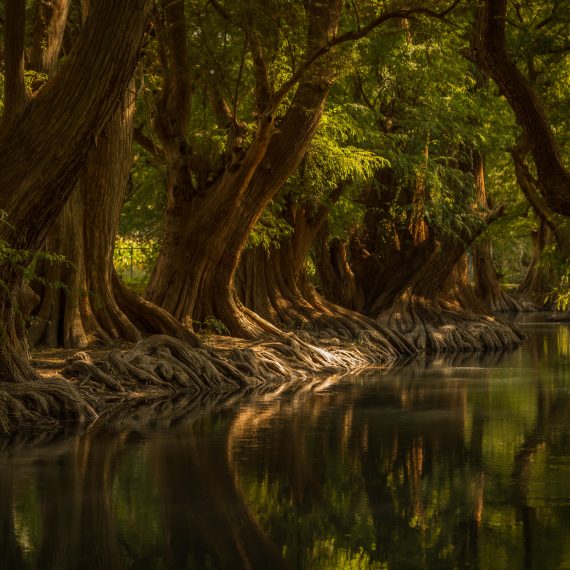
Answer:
[0,318,570,570]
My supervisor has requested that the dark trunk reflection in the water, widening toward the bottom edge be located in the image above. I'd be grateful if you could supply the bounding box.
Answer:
[156,412,286,569]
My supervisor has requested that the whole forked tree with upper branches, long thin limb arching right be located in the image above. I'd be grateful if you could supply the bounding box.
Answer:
[140,0,455,337]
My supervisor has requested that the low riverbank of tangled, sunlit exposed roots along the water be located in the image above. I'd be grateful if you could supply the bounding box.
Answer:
[0,319,524,436]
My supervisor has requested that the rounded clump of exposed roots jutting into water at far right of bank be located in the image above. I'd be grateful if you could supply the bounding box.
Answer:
[378,295,524,353]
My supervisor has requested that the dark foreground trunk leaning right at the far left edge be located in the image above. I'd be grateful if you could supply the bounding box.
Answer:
[0,0,151,404]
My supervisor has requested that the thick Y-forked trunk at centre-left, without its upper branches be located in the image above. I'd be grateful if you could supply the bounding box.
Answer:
[146,0,341,337]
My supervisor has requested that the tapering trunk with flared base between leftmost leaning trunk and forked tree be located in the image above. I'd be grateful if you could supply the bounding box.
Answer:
[29,82,199,347]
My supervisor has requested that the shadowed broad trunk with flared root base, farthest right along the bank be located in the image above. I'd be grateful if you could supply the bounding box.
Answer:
[346,165,521,352]
